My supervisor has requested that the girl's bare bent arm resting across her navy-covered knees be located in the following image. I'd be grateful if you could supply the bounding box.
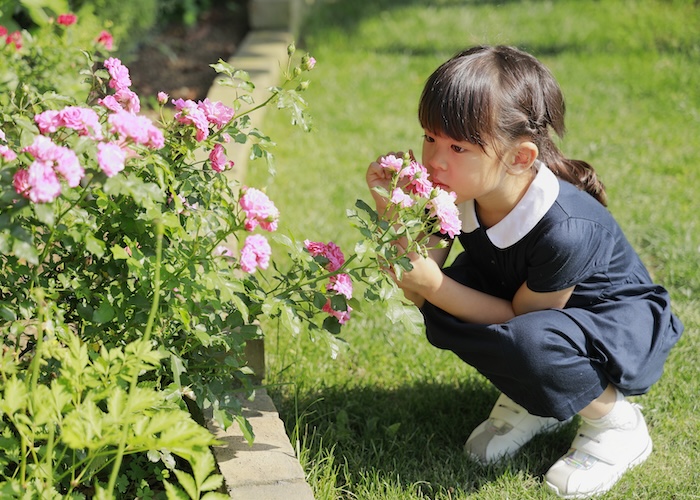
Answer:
[397,256,573,324]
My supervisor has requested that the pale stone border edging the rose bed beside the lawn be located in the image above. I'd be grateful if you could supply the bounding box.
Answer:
[201,0,314,500]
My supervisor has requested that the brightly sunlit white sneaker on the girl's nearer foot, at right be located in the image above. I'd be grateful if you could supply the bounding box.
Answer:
[545,403,652,498]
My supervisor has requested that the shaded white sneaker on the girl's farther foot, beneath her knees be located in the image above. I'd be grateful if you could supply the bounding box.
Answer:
[464,394,568,464]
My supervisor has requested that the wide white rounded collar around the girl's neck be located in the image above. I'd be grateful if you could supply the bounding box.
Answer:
[459,160,559,249]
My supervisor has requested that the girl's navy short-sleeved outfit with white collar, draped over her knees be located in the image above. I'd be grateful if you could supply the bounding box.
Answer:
[421,162,683,420]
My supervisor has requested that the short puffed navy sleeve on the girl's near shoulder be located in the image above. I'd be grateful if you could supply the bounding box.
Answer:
[527,218,615,293]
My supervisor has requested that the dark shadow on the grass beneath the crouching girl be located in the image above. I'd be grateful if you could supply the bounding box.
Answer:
[270,380,576,498]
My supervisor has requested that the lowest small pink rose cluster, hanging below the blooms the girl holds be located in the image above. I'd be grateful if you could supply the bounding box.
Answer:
[304,240,352,325]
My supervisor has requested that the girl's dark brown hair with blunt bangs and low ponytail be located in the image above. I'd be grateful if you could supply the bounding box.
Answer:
[418,46,606,205]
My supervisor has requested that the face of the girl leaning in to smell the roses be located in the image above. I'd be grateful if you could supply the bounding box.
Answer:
[422,130,510,204]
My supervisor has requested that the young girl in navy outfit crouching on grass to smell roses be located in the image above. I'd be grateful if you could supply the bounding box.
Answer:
[367,46,683,498]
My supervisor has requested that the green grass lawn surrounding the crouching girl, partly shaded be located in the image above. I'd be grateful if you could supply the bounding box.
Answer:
[246,0,700,500]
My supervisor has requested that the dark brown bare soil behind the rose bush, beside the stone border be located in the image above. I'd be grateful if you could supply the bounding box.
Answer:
[127,0,248,101]
